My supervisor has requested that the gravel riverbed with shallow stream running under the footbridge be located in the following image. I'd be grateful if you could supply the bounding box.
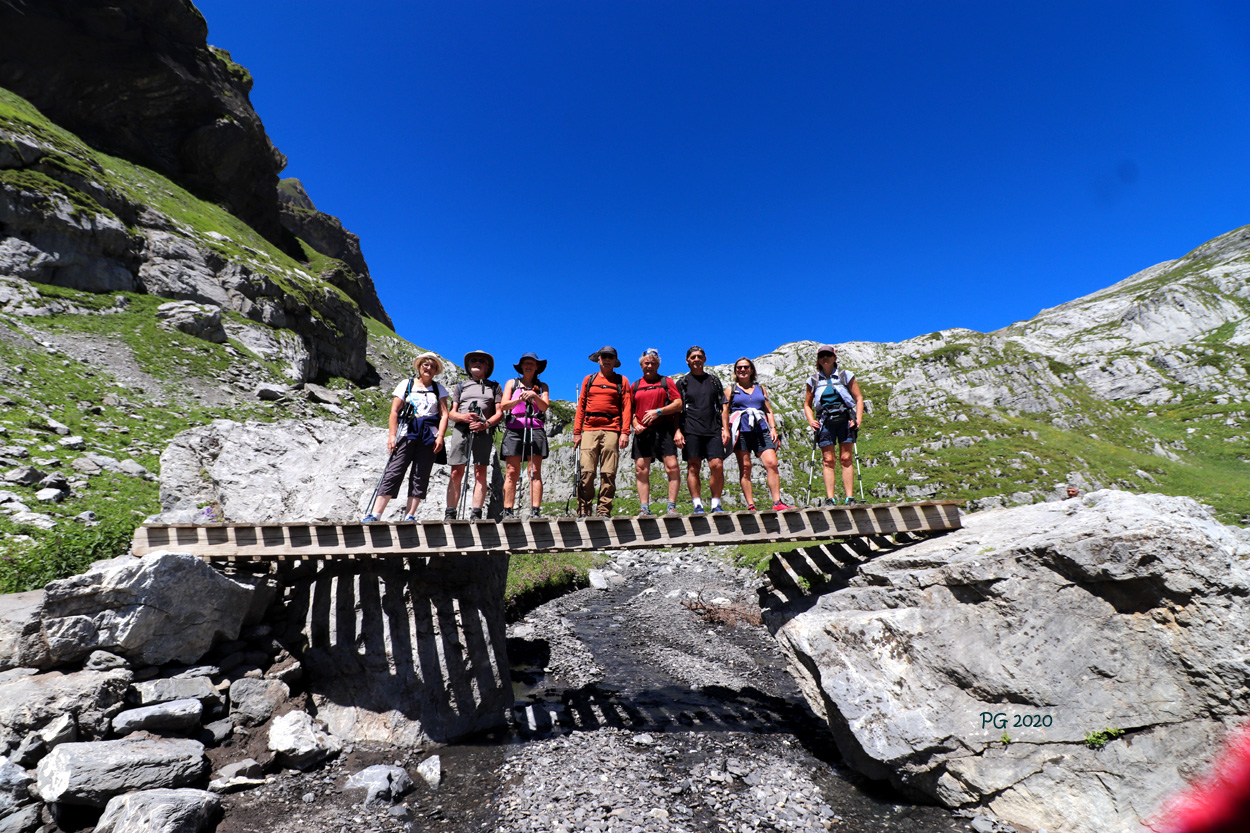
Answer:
[218,550,1014,833]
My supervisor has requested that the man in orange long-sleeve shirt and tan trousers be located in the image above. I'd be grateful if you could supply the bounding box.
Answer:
[573,346,634,518]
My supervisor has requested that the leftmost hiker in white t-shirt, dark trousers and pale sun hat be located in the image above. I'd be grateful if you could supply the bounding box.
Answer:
[363,353,448,524]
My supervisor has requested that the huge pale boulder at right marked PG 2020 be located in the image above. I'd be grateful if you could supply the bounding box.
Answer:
[765,492,1250,833]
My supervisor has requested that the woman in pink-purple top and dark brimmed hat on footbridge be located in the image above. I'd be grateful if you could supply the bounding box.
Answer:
[500,353,551,518]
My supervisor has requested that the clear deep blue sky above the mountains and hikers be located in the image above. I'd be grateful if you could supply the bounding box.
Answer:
[198,0,1250,398]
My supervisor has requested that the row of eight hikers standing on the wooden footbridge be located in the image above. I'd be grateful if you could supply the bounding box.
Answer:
[363,344,864,523]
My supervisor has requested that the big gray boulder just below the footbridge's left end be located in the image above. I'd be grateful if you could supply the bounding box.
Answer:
[43,553,251,665]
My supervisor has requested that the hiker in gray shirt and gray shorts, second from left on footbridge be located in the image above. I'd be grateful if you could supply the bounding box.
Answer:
[446,350,504,520]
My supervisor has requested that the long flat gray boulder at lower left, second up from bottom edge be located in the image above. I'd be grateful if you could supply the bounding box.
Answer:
[36,738,208,807]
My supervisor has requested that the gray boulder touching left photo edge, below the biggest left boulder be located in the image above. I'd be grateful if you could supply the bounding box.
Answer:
[0,668,130,745]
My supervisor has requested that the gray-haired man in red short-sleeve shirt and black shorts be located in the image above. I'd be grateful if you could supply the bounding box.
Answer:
[630,348,681,515]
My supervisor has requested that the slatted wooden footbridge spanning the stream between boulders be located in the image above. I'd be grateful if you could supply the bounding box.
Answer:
[133,500,961,562]
